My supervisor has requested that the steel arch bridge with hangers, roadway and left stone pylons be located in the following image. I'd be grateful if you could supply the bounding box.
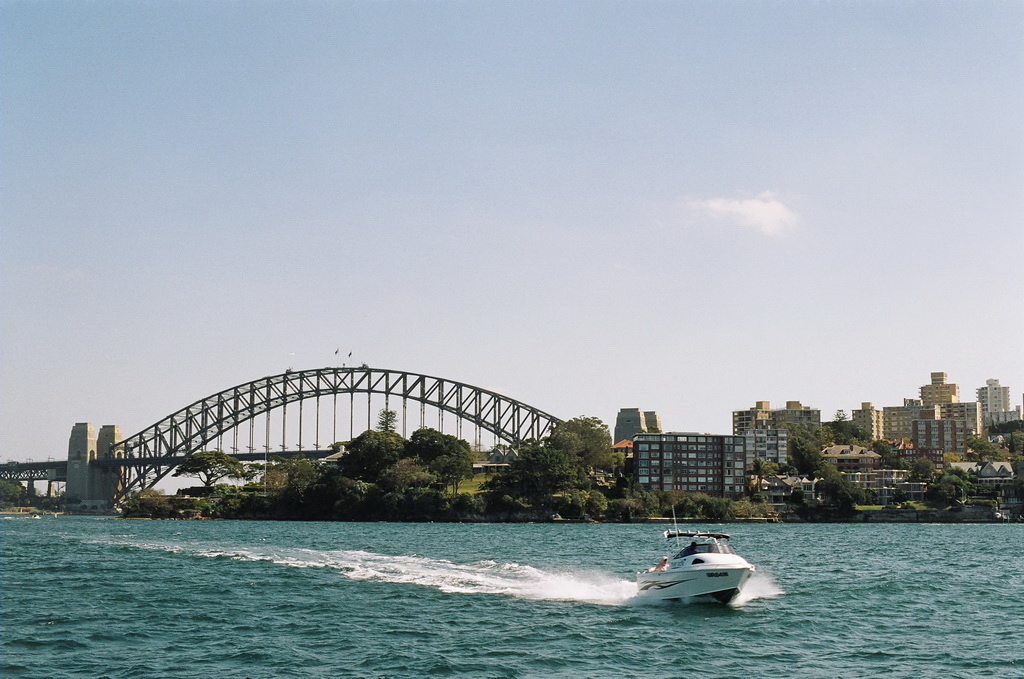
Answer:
[0,366,560,510]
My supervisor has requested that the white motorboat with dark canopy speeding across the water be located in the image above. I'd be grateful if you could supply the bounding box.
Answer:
[637,529,754,603]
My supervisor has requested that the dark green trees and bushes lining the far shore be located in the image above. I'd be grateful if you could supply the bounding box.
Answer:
[117,410,1015,521]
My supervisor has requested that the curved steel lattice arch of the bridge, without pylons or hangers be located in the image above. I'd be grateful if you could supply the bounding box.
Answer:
[109,366,561,505]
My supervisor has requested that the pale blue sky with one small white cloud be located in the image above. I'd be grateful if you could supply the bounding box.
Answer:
[0,0,1024,461]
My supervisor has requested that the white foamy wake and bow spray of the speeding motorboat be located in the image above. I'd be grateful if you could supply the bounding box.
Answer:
[97,542,781,605]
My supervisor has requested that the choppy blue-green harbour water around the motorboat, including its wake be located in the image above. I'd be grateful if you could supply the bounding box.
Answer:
[0,517,1024,679]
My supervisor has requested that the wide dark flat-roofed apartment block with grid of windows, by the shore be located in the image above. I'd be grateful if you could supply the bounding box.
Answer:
[633,432,746,500]
